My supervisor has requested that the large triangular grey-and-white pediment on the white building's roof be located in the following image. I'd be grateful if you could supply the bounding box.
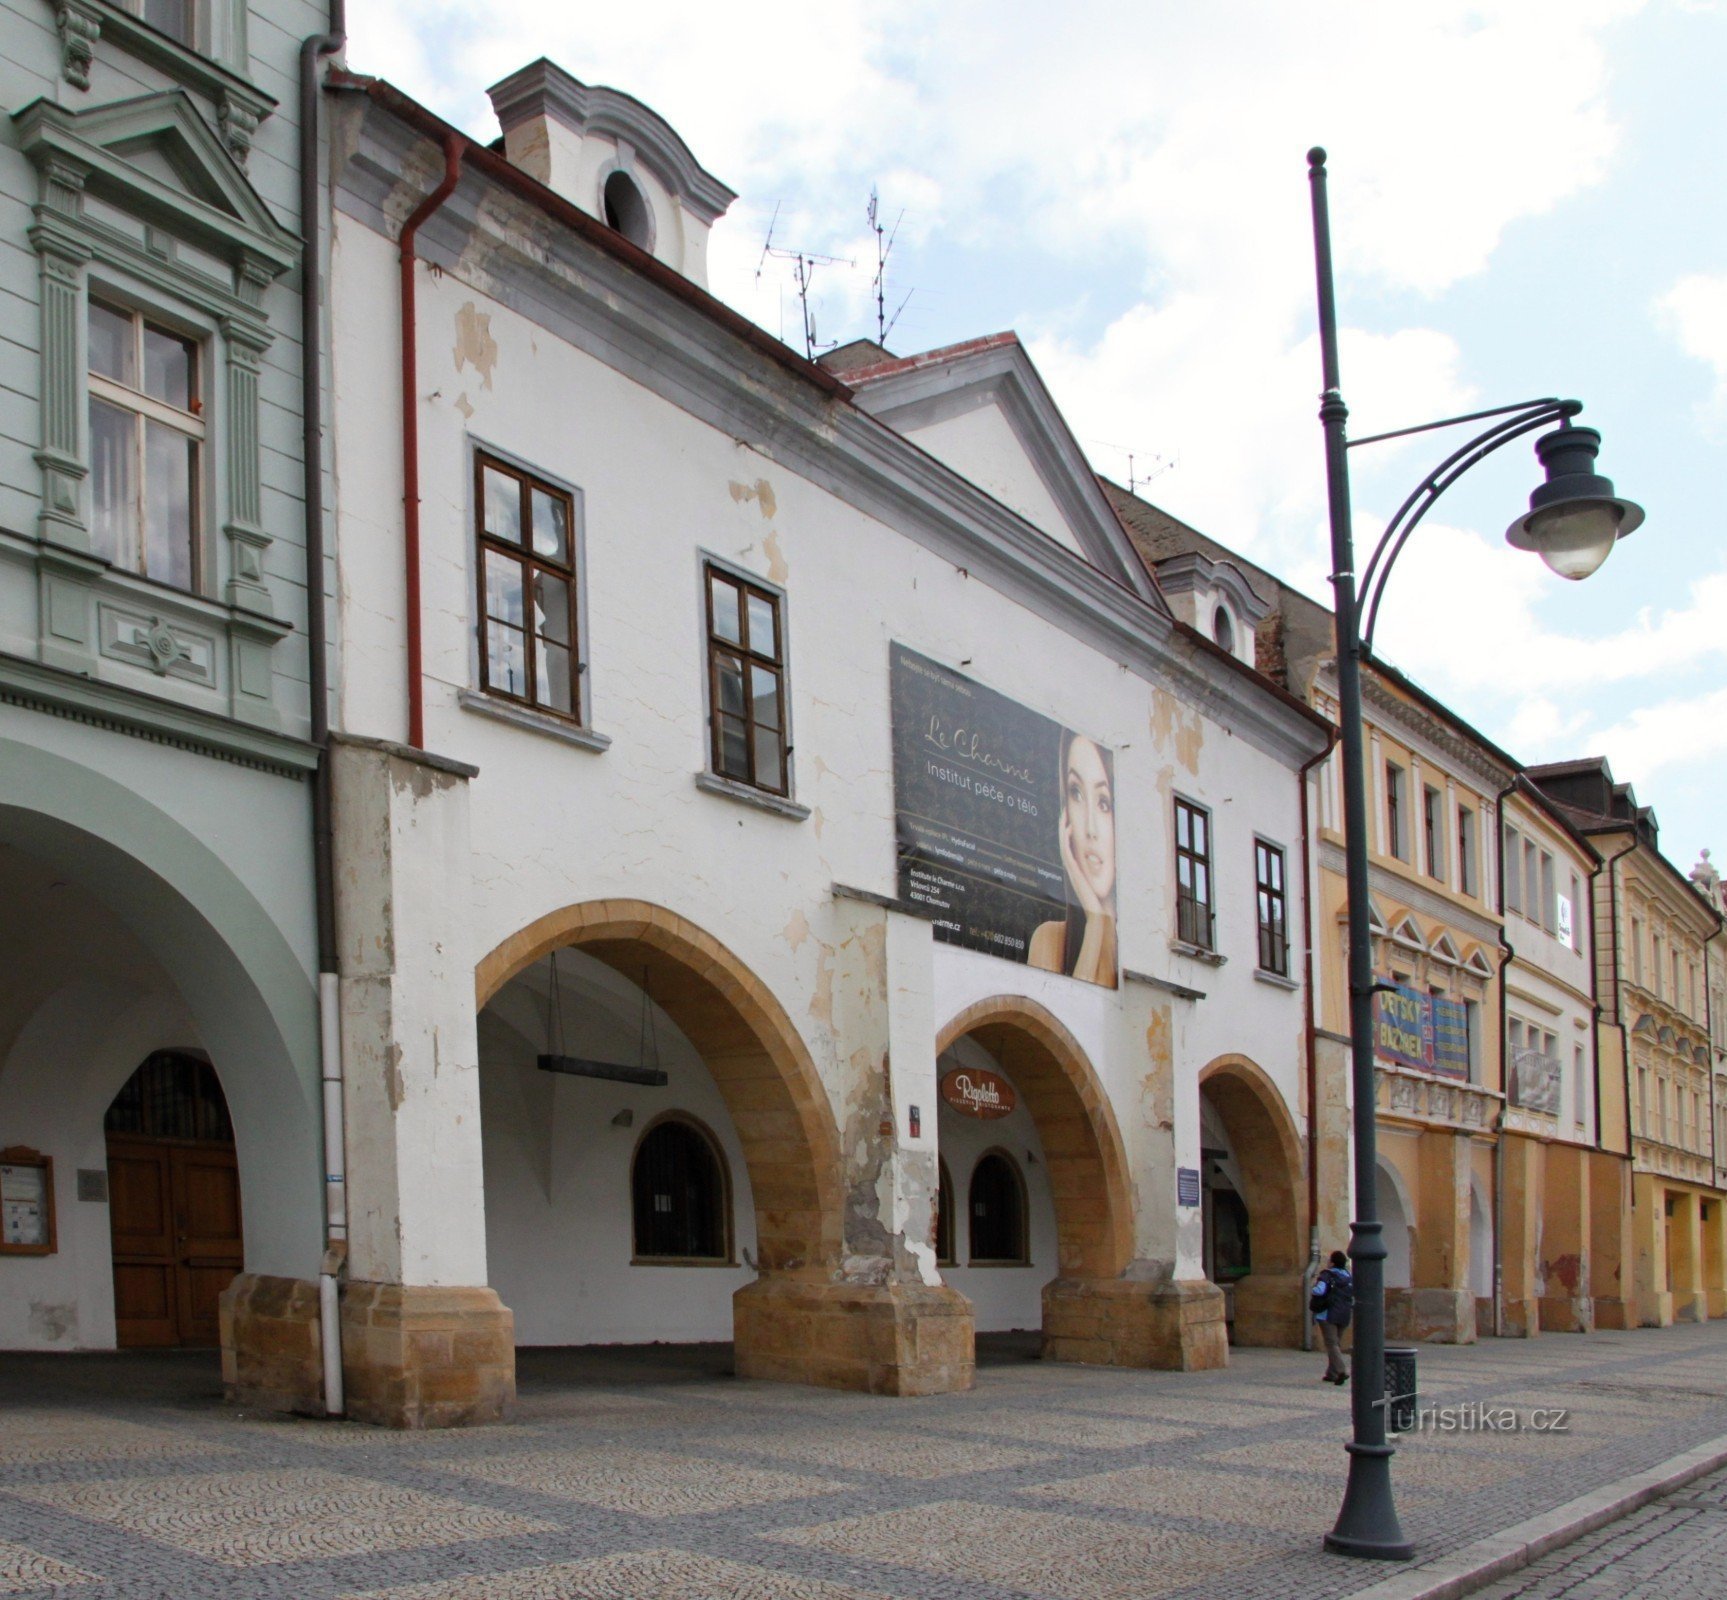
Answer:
[841,333,1169,615]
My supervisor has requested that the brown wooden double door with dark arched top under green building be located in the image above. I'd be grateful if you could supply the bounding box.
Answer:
[104,1051,245,1349]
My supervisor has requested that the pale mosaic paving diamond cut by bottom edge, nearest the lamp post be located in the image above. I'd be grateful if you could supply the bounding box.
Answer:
[769,1500,1266,1600]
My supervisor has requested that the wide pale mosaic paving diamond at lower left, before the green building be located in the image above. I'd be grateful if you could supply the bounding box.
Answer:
[10,1469,554,1567]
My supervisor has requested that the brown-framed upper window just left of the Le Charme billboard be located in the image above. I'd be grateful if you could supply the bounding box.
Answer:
[703,562,791,795]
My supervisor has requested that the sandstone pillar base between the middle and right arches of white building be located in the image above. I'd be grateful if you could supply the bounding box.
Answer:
[1043,1279,1245,1372]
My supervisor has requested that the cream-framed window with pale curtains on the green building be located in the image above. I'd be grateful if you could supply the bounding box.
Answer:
[90,299,204,589]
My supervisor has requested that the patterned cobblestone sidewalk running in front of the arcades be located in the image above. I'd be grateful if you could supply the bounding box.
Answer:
[0,1322,1727,1600]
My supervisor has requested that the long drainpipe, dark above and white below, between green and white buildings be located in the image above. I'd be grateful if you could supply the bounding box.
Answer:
[299,0,347,1417]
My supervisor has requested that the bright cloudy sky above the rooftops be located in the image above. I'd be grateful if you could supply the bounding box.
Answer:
[349,0,1727,871]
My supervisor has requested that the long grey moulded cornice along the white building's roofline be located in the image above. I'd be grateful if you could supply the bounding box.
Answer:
[335,100,1325,777]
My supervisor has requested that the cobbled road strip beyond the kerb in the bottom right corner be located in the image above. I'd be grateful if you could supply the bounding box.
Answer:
[1477,1469,1727,1600]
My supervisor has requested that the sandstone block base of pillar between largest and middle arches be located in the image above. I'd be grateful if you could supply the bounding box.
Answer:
[732,1277,977,1394]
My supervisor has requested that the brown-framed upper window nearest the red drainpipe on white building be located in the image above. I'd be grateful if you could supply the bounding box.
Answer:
[473,454,582,722]
